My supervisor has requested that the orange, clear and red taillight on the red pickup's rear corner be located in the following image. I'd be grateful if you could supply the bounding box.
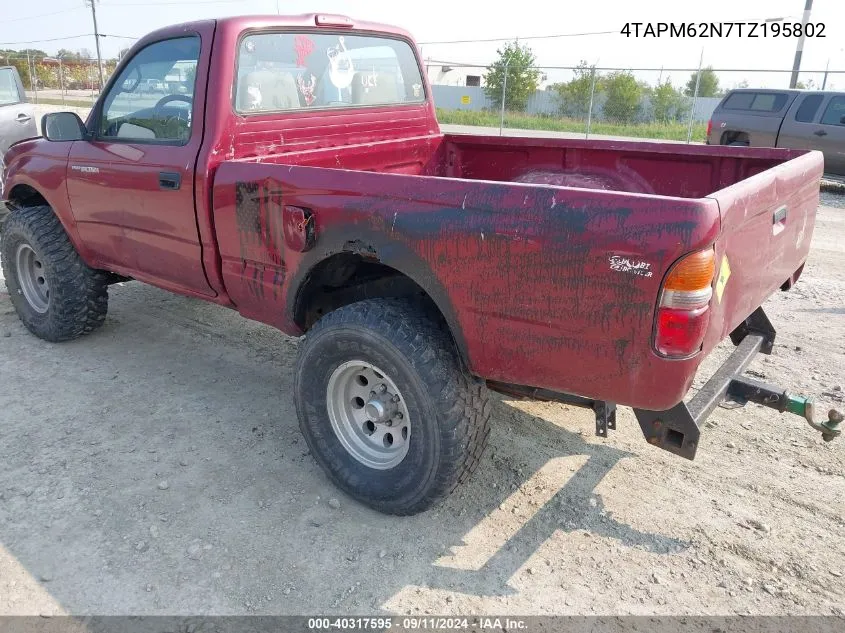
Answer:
[654,248,716,358]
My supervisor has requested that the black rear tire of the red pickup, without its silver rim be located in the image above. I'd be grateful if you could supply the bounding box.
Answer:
[295,299,492,515]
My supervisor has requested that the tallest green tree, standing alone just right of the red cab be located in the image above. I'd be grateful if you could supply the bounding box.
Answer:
[484,42,540,112]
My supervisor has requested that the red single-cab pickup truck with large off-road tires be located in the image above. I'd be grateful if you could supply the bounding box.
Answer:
[1,14,841,514]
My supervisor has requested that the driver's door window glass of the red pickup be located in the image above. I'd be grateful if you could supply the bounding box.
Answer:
[99,36,200,144]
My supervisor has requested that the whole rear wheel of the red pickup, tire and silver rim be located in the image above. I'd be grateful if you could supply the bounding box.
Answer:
[295,299,491,514]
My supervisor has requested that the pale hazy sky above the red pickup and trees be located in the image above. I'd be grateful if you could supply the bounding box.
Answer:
[0,0,845,88]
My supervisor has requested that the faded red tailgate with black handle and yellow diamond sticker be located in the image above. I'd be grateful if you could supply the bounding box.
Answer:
[704,151,824,351]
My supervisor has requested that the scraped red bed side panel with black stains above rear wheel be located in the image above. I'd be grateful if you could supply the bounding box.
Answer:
[213,161,720,409]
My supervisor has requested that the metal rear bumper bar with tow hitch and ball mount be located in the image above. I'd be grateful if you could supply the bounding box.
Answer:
[634,308,843,459]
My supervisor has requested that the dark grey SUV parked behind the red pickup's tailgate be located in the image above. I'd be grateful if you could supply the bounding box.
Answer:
[707,89,845,176]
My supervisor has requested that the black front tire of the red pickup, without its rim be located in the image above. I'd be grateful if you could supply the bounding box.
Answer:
[0,206,109,342]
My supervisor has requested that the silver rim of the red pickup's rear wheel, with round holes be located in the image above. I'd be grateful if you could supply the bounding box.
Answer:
[326,360,411,470]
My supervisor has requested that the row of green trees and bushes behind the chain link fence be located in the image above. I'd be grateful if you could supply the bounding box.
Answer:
[484,42,723,123]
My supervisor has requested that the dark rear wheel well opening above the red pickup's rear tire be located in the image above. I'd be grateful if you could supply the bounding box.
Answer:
[294,252,466,360]
